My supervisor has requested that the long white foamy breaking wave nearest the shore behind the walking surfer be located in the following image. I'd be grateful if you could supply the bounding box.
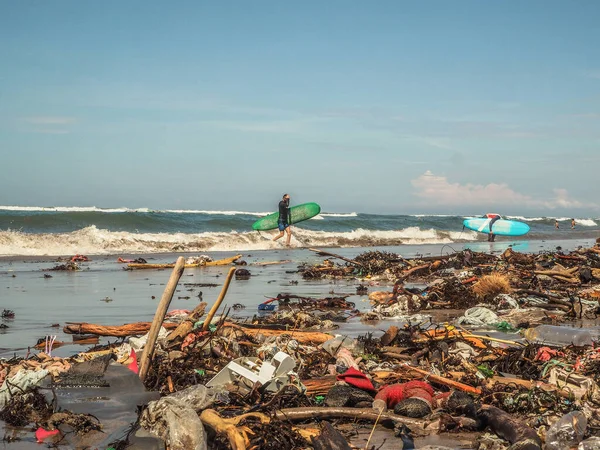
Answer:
[0,225,477,256]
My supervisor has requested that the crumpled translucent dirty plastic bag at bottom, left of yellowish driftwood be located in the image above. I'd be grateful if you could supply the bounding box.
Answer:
[140,384,226,450]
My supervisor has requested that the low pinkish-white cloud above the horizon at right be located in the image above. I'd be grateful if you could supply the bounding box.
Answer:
[411,170,595,209]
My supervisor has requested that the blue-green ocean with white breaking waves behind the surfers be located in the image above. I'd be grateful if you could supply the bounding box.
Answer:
[0,206,600,256]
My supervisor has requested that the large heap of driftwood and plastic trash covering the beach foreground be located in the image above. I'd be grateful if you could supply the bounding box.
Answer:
[0,247,600,450]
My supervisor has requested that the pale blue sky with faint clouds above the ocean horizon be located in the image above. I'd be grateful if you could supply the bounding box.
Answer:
[0,0,600,215]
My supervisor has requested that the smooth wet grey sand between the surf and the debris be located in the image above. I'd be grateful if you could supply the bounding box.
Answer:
[0,239,593,358]
